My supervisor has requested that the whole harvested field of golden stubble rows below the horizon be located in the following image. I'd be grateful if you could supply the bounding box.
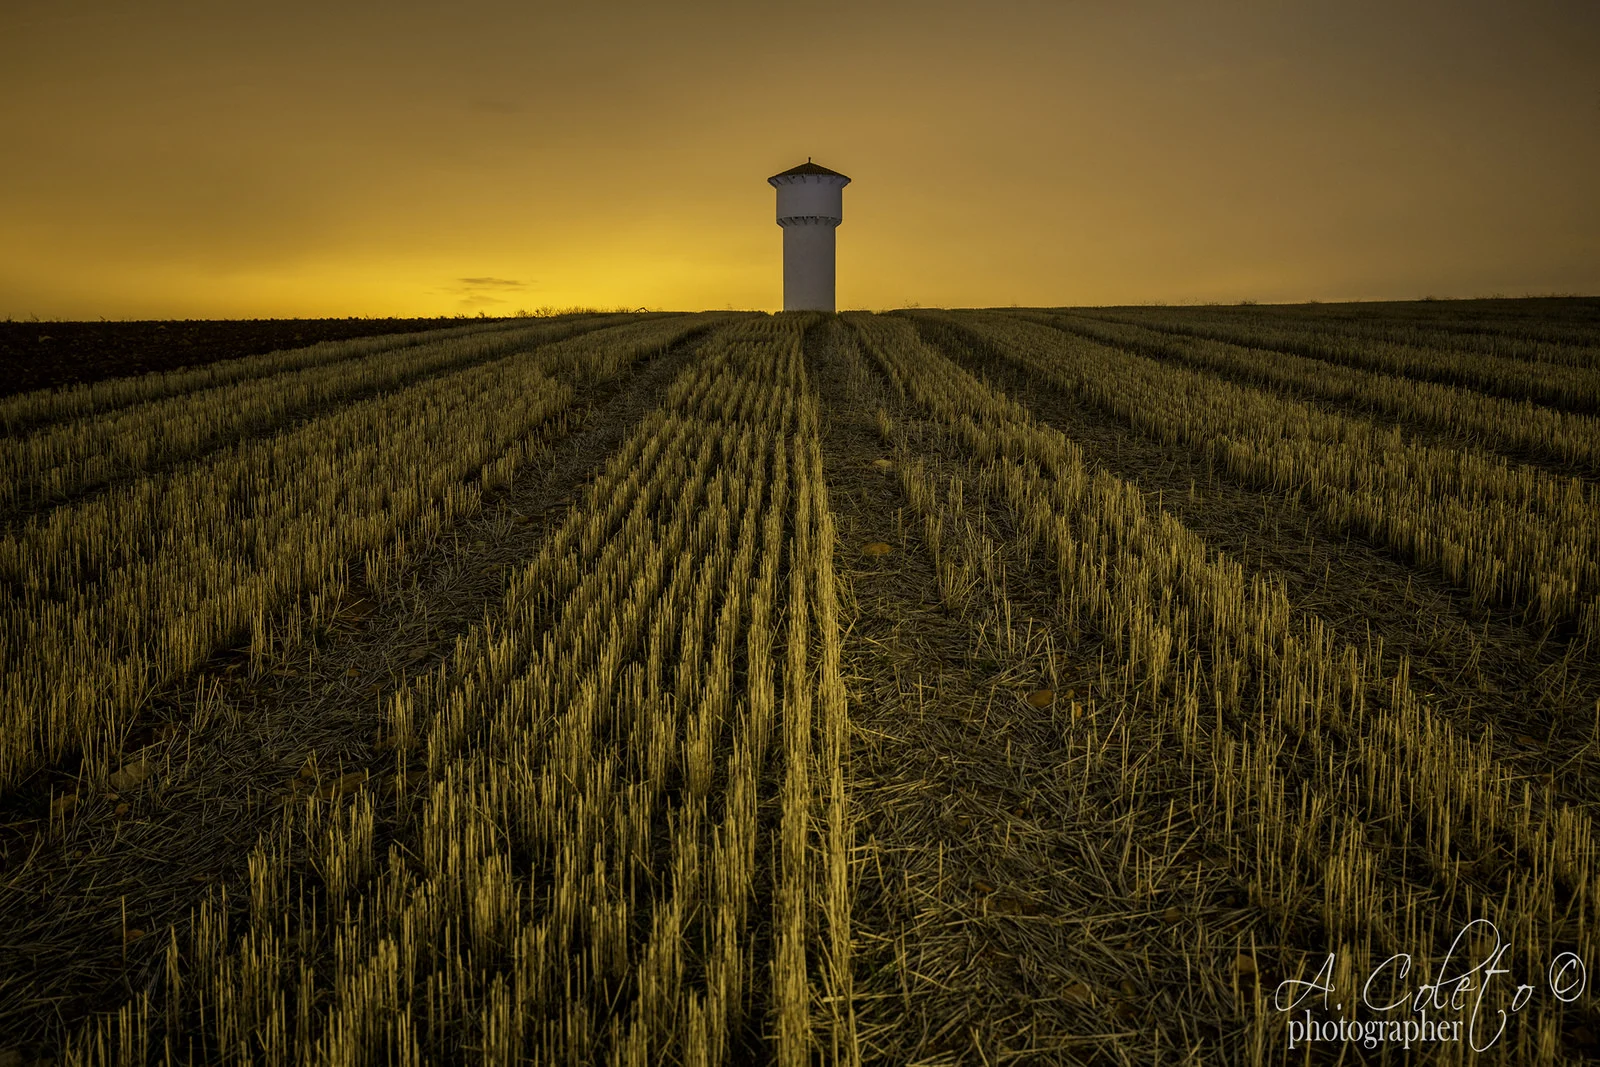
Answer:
[0,301,1600,1067]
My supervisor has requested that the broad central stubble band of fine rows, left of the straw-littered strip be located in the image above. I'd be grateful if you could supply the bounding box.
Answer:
[69,317,853,1067]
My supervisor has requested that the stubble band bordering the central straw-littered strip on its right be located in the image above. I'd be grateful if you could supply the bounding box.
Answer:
[846,315,1600,1062]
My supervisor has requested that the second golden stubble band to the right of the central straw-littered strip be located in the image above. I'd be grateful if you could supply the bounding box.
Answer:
[918,314,1600,641]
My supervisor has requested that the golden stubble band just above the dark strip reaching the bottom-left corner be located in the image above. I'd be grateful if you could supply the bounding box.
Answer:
[0,317,717,799]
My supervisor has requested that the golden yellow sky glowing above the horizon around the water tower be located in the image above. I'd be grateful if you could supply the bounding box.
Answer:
[0,0,1600,318]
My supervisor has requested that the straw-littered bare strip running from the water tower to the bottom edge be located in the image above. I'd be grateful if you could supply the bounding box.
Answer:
[808,319,1266,1064]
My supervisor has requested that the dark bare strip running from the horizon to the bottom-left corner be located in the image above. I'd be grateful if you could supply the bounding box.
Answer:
[0,338,704,1062]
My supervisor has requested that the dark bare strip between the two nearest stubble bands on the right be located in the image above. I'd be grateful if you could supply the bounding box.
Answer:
[918,313,1600,813]
